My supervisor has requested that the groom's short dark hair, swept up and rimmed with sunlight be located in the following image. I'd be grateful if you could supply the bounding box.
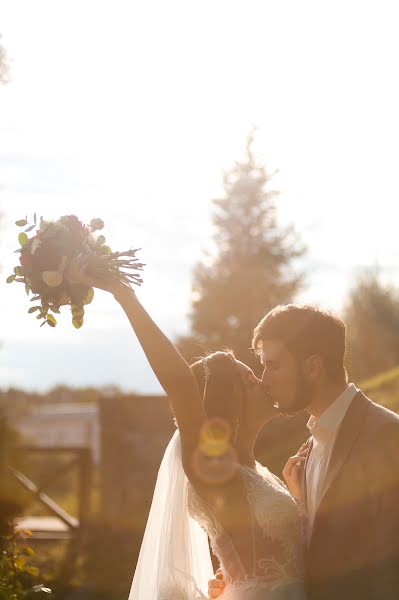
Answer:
[252,304,348,383]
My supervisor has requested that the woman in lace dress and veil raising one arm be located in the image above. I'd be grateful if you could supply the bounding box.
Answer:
[70,259,305,600]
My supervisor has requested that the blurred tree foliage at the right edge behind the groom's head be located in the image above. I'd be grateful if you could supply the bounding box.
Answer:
[344,272,399,381]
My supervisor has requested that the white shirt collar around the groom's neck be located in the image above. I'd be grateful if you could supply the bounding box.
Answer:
[307,383,359,443]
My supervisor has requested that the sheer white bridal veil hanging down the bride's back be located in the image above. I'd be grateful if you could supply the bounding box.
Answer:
[129,431,213,600]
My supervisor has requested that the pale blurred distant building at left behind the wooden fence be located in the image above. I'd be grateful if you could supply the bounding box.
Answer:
[11,402,101,464]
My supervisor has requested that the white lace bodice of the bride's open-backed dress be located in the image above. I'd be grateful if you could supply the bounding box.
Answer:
[188,463,303,598]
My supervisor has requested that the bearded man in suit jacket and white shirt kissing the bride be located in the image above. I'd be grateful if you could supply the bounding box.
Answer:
[209,305,399,600]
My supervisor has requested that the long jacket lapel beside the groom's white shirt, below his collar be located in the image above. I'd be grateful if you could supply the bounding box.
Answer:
[315,392,370,520]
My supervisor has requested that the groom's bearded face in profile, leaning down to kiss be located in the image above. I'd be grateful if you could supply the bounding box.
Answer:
[260,340,312,414]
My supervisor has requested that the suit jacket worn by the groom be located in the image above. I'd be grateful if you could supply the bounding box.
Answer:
[303,392,399,600]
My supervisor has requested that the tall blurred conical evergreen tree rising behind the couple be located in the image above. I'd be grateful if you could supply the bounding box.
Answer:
[180,133,304,366]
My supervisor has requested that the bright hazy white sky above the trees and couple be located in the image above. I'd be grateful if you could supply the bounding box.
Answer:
[0,0,399,393]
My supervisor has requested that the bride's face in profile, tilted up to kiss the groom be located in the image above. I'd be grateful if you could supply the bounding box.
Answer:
[236,360,277,425]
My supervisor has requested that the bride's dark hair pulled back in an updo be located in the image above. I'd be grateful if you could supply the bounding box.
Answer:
[191,350,245,432]
